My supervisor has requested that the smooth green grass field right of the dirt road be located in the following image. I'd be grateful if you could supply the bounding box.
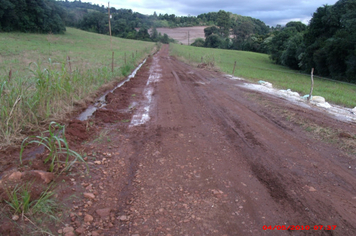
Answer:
[170,44,356,108]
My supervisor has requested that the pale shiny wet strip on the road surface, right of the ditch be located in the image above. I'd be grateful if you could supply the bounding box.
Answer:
[130,57,162,127]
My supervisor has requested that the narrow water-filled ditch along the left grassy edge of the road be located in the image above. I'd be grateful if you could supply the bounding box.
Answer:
[77,59,146,121]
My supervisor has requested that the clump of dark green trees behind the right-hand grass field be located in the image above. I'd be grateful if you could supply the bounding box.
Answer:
[269,0,356,83]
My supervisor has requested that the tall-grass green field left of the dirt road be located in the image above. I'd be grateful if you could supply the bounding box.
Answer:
[0,28,155,146]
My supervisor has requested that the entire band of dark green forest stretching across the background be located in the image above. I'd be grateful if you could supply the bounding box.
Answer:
[0,0,356,83]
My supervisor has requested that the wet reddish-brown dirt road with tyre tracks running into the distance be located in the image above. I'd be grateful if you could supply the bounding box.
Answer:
[55,46,356,236]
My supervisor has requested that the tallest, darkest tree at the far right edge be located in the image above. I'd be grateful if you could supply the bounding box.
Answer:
[303,0,356,82]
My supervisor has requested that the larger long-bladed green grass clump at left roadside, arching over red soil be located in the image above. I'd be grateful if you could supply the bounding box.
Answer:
[20,121,85,172]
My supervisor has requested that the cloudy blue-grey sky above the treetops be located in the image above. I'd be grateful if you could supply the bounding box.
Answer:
[89,0,337,26]
